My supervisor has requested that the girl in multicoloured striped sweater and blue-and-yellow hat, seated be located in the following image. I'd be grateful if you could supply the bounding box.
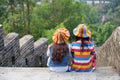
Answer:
[71,24,96,72]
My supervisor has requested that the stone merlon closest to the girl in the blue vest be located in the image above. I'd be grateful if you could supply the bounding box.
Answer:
[34,38,48,66]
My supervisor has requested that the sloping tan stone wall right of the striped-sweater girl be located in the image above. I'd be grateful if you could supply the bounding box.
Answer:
[97,27,120,72]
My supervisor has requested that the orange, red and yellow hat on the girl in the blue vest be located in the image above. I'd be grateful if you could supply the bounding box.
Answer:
[52,28,70,44]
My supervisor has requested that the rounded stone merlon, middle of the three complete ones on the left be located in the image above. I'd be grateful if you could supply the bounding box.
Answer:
[18,35,34,67]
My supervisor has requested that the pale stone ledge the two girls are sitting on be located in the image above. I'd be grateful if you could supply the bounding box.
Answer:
[0,67,120,80]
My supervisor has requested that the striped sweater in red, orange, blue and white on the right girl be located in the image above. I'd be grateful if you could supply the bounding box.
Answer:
[71,41,96,72]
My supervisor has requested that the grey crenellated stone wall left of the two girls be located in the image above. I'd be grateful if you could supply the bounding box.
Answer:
[0,25,48,67]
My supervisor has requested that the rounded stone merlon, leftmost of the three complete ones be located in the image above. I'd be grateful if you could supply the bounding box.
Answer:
[2,33,20,67]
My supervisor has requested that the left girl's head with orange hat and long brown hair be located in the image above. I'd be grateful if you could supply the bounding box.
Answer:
[52,28,70,62]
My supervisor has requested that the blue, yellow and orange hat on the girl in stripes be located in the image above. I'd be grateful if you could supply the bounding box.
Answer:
[73,24,91,38]
